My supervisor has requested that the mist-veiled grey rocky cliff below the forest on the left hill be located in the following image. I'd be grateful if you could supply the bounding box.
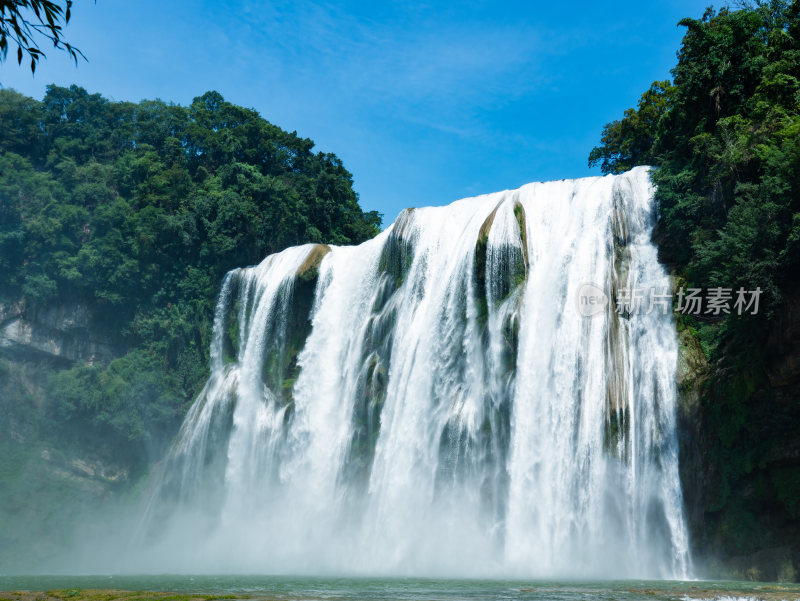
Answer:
[0,298,131,570]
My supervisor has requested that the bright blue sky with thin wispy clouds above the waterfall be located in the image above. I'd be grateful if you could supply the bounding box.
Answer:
[0,0,709,223]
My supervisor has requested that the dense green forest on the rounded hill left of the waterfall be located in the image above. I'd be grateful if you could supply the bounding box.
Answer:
[0,86,381,463]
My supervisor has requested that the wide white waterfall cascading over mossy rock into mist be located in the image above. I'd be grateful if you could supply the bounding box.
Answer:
[134,168,690,578]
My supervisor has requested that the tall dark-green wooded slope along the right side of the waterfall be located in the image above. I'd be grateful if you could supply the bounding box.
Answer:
[589,0,800,579]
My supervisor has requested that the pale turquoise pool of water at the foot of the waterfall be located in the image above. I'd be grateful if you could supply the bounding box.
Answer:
[0,575,800,601]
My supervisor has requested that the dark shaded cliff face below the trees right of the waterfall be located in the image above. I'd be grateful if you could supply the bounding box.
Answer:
[678,295,800,581]
